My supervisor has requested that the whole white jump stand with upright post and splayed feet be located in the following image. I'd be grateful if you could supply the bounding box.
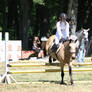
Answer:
[0,32,16,84]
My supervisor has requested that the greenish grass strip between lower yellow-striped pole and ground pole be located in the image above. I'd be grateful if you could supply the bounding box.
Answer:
[12,72,92,82]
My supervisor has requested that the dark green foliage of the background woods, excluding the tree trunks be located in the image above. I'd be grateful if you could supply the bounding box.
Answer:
[0,0,92,49]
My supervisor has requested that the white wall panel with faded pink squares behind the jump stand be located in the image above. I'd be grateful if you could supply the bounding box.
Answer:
[0,32,22,62]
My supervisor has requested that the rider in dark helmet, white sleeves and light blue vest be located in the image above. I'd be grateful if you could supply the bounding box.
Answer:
[50,13,69,52]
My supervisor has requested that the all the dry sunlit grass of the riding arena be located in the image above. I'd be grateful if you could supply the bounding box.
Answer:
[0,60,92,92]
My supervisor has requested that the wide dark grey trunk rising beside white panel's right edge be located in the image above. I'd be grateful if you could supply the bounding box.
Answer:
[19,0,30,49]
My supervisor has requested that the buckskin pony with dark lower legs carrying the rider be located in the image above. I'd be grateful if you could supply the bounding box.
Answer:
[46,35,77,85]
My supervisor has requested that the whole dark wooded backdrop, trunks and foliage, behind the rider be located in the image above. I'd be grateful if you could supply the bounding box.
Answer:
[0,0,92,49]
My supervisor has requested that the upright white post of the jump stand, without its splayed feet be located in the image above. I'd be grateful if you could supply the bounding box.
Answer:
[5,32,9,74]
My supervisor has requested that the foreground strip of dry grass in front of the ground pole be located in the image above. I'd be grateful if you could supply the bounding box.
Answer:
[0,82,92,92]
